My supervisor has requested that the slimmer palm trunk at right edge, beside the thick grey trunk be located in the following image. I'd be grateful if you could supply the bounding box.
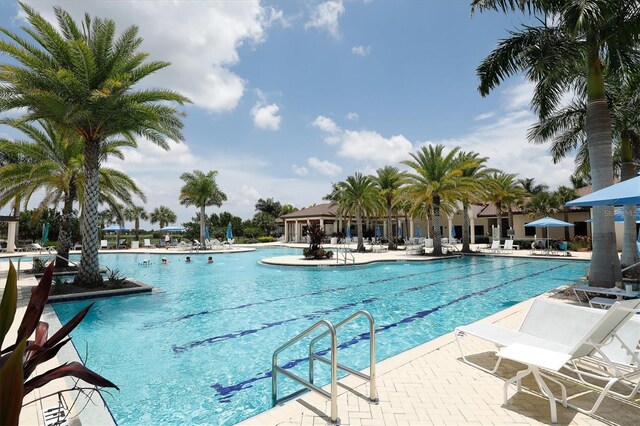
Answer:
[620,132,640,273]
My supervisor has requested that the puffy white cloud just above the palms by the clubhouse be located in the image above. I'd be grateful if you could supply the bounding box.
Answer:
[338,130,413,165]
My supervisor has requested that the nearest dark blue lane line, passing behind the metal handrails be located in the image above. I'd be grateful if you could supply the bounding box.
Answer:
[211,265,567,403]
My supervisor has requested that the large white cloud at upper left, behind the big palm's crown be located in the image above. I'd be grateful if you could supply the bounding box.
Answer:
[27,0,284,112]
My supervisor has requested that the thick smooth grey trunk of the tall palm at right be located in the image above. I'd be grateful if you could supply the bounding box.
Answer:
[586,39,622,287]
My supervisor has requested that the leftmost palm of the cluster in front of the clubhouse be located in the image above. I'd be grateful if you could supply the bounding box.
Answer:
[331,173,380,252]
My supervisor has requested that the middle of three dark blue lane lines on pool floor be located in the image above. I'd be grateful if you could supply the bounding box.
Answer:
[172,262,528,353]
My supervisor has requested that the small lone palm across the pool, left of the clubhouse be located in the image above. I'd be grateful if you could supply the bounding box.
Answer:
[179,170,227,246]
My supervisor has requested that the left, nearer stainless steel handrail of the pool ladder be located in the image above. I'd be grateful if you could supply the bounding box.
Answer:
[271,320,340,423]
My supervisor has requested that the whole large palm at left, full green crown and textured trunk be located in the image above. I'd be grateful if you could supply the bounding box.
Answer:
[0,3,188,286]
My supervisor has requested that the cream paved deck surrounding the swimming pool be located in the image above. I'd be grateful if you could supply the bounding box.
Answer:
[0,245,640,425]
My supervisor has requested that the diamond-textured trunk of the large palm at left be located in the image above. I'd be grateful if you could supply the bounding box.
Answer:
[76,141,102,287]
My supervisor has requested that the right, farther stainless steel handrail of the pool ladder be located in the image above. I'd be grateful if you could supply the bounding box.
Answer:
[309,310,378,402]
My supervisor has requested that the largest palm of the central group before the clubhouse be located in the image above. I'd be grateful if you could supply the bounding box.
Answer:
[402,145,476,255]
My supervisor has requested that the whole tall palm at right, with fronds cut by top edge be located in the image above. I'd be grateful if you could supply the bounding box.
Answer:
[471,0,640,287]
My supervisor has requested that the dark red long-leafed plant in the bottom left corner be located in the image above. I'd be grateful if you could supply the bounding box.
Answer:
[0,263,118,425]
